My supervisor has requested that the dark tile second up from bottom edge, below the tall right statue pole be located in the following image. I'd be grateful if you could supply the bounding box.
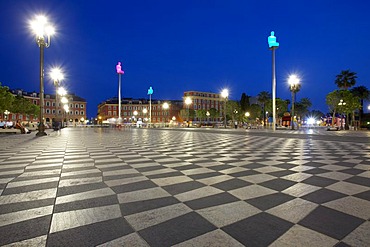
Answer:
[245,193,295,211]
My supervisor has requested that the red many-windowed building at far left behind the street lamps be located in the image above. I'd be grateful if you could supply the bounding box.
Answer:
[5,89,87,126]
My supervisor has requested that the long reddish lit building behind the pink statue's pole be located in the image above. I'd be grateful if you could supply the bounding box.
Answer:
[96,98,182,123]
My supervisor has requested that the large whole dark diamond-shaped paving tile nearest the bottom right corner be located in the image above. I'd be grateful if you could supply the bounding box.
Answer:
[298,206,364,240]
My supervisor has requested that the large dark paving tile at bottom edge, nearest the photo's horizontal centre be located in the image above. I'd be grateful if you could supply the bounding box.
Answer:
[139,212,217,247]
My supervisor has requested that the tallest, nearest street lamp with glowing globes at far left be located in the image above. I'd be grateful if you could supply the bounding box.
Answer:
[30,16,54,136]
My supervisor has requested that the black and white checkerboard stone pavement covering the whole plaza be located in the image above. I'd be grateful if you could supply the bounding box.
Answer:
[0,128,370,246]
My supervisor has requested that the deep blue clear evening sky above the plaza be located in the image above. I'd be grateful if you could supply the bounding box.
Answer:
[0,0,370,117]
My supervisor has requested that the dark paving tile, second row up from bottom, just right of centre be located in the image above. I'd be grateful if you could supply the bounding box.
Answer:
[185,192,239,210]
